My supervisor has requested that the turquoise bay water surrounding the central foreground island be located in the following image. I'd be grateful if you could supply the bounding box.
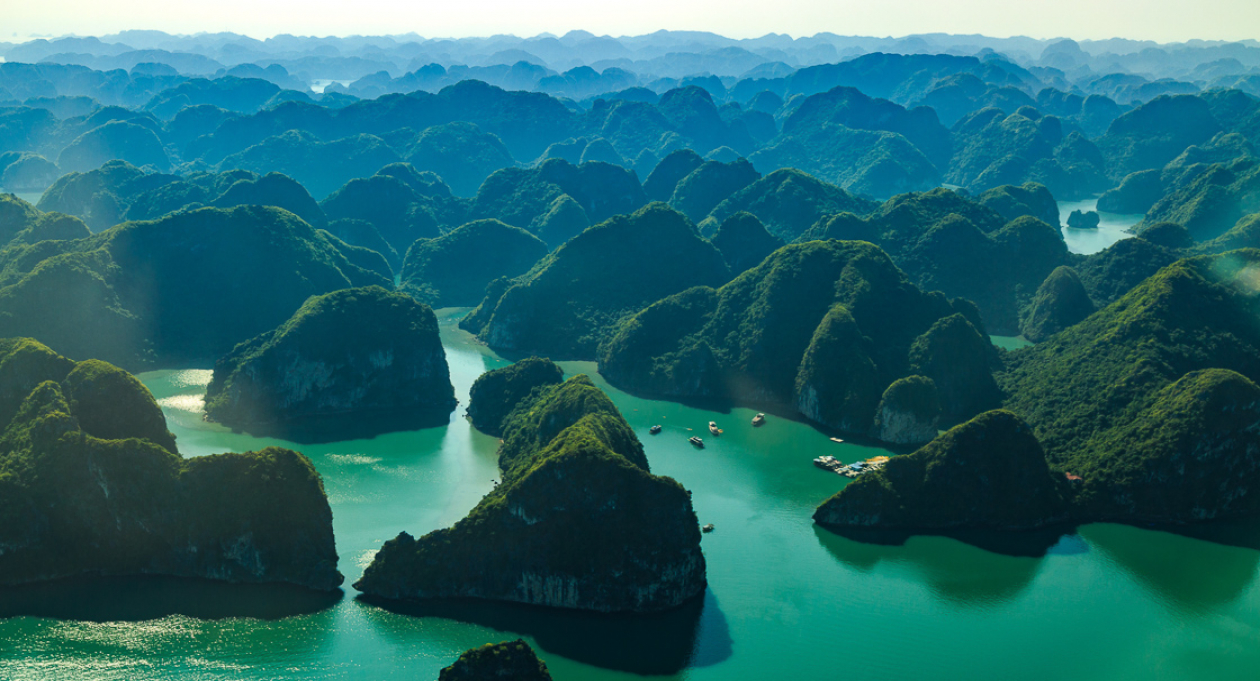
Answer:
[0,310,1260,681]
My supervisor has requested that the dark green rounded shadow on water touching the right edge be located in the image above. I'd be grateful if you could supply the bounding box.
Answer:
[1081,521,1260,613]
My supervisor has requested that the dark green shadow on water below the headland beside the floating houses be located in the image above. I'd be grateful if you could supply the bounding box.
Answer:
[814,526,1063,607]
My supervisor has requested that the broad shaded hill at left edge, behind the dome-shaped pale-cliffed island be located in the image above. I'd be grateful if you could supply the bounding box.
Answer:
[0,206,391,368]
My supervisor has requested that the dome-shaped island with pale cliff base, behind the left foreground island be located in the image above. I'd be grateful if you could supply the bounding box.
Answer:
[205,286,455,428]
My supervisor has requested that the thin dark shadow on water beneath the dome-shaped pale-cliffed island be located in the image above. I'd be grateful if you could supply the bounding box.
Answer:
[224,410,454,445]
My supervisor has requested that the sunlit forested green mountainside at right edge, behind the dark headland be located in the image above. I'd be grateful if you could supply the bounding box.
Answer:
[998,250,1260,522]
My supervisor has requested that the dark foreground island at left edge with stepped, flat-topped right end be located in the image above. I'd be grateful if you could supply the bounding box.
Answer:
[0,339,341,590]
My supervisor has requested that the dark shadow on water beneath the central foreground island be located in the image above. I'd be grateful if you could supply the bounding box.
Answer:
[358,590,732,675]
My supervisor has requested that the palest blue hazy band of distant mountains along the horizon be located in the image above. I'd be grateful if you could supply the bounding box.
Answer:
[7,30,1260,105]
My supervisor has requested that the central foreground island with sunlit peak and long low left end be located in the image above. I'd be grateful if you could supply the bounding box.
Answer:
[355,376,706,613]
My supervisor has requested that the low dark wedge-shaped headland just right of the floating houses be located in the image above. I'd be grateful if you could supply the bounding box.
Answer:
[814,411,1070,530]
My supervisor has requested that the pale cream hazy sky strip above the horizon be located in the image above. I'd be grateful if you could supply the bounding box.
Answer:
[7,0,1260,42]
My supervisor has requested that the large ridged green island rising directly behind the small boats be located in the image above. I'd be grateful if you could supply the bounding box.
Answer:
[600,241,995,434]
